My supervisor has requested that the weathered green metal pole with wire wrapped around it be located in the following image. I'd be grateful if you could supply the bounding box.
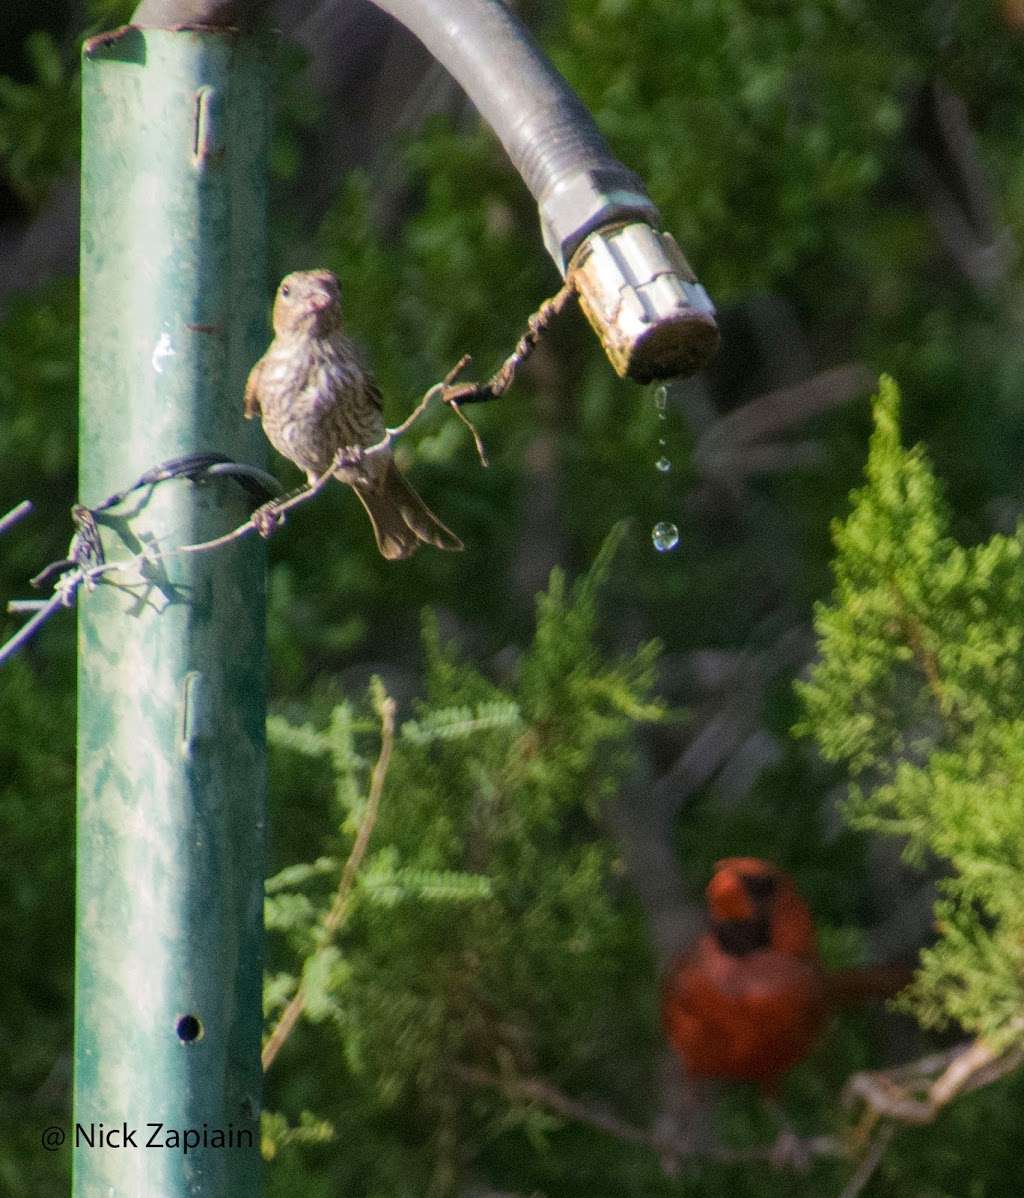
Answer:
[72,28,267,1198]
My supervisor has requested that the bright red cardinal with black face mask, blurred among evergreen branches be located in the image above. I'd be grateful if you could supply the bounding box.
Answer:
[661,857,911,1089]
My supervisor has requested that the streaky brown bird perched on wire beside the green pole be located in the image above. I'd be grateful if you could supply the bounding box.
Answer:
[246,270,462,558]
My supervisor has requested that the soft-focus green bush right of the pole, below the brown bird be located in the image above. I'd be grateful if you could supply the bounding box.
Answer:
[266,528,662,1196]
